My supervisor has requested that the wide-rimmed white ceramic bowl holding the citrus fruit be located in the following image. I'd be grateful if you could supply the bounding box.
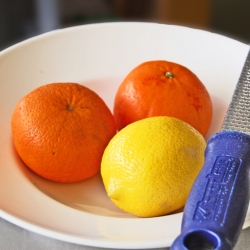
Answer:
[0,23,250,249]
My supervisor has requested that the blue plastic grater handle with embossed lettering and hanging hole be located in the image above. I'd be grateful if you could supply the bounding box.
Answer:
[170,130,250,250]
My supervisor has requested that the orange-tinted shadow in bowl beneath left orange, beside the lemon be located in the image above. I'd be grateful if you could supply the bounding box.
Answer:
[13,146,134,218]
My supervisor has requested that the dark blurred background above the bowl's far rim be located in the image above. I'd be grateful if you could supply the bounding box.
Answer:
[0,0,250,50]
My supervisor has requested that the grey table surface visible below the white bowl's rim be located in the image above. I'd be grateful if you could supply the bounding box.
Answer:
[0,218,250,250]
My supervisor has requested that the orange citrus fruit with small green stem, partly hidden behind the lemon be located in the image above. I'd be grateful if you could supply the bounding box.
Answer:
[114,60,212,136]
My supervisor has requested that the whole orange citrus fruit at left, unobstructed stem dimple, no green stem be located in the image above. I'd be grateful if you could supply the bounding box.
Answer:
[12,83,116,182]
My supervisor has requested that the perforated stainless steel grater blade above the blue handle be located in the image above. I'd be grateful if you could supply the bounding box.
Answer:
[221,51,250,134]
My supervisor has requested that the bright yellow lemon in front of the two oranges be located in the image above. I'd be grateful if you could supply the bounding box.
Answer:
[101,116,206,217]
